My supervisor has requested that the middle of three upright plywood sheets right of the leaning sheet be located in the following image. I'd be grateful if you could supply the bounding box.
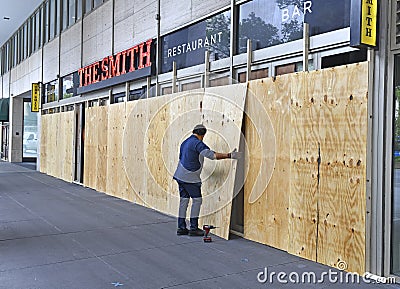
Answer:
[288,71,322,261]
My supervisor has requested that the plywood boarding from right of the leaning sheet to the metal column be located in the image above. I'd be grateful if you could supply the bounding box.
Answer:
[244,63,368,273]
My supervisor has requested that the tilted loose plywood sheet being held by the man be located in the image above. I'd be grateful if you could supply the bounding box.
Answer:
[200,84,247,239]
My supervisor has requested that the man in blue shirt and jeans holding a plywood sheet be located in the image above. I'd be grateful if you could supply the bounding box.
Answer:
[174,124,240,236]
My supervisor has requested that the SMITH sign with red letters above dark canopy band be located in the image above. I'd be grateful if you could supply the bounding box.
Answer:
[78,39,154,94]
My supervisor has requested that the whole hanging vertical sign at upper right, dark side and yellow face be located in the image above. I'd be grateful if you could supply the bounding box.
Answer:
[350,0,378,47]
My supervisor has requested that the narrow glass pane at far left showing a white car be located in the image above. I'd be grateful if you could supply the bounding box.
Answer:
[22,102,38,158]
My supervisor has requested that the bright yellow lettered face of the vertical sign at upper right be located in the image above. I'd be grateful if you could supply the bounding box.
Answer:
[361,0,378,46]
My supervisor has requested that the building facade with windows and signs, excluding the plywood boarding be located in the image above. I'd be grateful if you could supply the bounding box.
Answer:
[0,0,400,276]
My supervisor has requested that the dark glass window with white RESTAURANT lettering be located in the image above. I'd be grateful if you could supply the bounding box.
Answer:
[161,11,231,73]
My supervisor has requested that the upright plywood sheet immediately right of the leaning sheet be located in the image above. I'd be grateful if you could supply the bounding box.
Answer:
[244,75,291,250]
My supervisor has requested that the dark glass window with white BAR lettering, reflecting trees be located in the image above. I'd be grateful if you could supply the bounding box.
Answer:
[237,0,351,54]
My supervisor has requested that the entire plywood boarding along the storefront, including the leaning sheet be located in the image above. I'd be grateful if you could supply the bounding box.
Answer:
[40,63,368,273]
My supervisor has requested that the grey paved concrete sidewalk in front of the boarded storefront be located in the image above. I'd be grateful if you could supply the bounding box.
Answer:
[0,162,400,289]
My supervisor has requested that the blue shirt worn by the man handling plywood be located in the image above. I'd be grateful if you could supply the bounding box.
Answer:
[174,135,215,183]
